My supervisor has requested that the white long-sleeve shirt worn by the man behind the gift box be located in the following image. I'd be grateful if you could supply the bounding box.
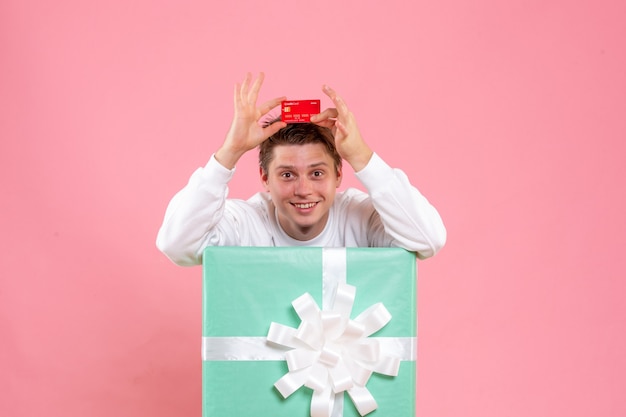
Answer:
[157,154,446,266]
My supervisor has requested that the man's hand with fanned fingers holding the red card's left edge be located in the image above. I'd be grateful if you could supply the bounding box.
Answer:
[215,73,286,169]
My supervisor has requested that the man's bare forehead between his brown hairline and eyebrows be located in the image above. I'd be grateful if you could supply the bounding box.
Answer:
[268,143,334,169]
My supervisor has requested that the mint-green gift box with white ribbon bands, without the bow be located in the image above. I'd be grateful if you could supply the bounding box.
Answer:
[202,247,417,417]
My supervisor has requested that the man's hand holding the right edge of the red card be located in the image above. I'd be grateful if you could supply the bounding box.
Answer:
[311,85,373,172]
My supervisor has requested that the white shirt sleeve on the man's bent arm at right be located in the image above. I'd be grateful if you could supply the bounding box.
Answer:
[355,153,446,259]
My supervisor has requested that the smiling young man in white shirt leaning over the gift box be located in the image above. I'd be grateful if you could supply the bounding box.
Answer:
[157,74,446,266]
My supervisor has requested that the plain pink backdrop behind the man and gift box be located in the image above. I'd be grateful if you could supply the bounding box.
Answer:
[0,0,626,417]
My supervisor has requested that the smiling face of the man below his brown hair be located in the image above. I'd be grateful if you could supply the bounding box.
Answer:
[261,143,341,240]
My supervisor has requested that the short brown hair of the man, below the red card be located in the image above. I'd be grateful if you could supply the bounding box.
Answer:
[259,123,341,173]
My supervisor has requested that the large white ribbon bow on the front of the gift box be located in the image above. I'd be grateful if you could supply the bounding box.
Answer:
[267,283,400,417]
